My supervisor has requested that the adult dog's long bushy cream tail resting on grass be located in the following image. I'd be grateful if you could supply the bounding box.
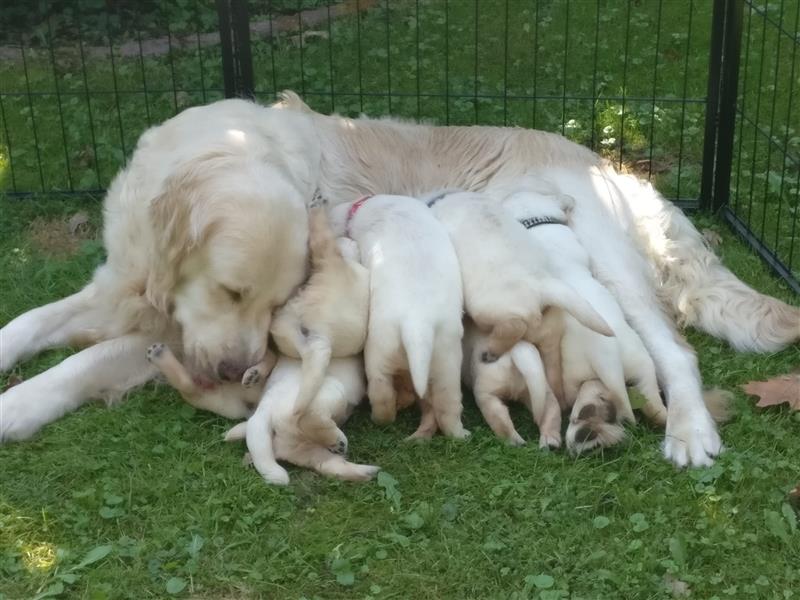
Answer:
[605,171,800,352]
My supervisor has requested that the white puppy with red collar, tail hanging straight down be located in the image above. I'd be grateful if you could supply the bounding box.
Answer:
[330,195,469,438]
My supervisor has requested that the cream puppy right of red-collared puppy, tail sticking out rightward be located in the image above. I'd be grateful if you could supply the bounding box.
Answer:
[427,192,613,402]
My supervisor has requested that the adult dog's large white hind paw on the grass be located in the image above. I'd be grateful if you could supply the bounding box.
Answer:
[664,410,722,468]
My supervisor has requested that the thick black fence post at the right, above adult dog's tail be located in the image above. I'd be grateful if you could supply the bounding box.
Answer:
[700,0,744,212]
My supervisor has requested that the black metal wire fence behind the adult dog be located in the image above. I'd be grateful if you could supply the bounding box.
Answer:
[0,0,800,291]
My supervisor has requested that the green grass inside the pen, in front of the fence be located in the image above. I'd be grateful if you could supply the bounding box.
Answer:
[0,198,800,600]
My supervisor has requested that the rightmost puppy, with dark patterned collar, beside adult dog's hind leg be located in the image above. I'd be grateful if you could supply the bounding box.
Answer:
[502,185,667,452]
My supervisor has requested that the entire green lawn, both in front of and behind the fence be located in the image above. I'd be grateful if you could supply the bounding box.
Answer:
[0,0,800,600]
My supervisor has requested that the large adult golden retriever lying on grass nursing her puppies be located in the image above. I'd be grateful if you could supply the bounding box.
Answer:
[0,94,800,466]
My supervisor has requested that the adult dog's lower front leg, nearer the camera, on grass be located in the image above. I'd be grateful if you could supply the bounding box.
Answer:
[0,334,157,442]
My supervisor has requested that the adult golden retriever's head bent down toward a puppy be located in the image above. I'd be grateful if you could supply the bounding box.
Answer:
[147,153,308,381]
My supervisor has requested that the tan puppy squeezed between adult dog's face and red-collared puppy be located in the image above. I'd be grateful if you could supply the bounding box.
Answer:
[270,207,369,447]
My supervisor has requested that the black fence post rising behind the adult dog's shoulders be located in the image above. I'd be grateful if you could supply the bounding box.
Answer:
[217,0,255,98]
